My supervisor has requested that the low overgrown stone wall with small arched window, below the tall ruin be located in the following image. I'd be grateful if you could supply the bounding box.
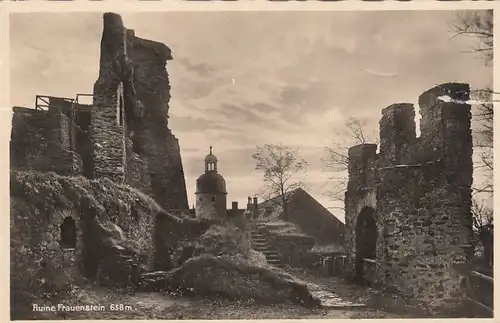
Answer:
[10,171,160,284]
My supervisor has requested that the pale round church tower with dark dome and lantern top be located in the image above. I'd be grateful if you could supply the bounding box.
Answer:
[195,146,227,219]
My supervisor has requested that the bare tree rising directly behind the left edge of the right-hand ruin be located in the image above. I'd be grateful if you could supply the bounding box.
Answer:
[322,117,378,210]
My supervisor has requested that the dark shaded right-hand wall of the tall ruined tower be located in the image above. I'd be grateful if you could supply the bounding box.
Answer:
[127,30,189,209]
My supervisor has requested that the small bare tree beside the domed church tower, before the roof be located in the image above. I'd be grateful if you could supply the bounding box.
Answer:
[252,144,307,221]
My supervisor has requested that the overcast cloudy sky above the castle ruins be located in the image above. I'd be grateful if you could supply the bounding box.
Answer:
[10,11,492,220]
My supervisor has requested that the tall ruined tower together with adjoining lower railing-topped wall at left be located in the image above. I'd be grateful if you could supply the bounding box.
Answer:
[11,13,188,210]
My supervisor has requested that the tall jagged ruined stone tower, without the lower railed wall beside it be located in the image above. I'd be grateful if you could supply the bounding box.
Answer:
[91,13,188,209]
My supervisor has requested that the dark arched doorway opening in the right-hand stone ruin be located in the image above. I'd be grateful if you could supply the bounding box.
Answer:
[355,207,377,278]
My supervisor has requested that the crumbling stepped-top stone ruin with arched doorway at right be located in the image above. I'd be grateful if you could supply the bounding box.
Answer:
[345,83,472,309]
